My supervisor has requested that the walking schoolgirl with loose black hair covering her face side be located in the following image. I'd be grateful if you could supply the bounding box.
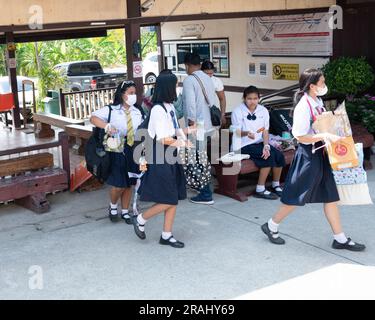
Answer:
[133,72,192,248]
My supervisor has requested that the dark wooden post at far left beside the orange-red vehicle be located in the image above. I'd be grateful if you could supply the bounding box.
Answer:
[5,32,21,129]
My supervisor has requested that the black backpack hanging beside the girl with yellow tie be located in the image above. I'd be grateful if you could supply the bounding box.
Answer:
[85,106,112,183]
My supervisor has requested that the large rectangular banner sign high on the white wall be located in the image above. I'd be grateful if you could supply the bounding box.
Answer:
[247,12,333,57]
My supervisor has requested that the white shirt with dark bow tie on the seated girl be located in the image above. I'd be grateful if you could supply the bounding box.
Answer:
[232,103,270,151]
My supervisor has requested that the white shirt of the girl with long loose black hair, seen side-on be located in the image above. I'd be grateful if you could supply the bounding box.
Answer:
[148,103,178,140]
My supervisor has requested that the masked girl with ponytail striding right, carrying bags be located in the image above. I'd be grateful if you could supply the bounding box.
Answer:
[262,69,365,251]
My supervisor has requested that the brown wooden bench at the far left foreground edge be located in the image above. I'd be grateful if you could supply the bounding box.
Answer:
[0,132,70,213]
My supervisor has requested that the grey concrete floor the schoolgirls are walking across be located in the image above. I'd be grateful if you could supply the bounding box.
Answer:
[0,160,375,299]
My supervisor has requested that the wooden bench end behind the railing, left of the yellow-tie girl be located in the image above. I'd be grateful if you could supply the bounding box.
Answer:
[33,112,85,138]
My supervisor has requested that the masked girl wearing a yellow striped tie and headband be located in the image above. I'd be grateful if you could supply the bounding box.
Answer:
[90,81,143,224]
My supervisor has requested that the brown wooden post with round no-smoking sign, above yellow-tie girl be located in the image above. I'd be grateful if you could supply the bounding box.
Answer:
[125,0,144,104]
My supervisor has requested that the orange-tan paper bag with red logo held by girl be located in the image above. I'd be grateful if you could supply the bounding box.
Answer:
[327,137,359,171]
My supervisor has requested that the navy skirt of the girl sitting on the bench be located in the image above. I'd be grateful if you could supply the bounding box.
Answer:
[241,142,286,168]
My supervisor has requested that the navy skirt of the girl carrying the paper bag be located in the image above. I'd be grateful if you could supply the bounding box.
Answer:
[281,143,340,206]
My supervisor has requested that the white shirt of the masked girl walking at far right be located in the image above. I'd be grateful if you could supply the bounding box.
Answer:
[292,95,326,145]
